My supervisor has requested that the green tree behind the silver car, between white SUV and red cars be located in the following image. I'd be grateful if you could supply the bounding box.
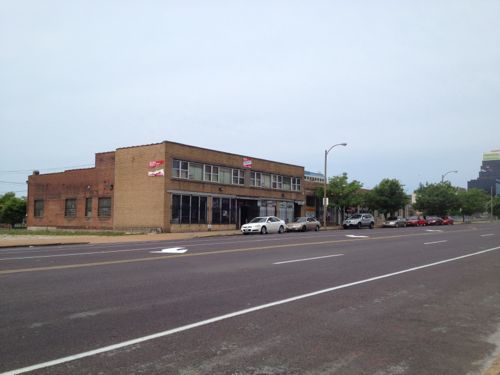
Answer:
[365,178,410,216]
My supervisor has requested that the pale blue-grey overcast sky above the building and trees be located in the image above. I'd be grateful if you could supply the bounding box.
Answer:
[0,0,500,195]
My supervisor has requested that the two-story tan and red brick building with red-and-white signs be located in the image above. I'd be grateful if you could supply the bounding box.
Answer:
[27,141,316,232]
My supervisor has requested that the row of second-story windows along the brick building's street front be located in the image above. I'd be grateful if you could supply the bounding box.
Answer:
[172,160,301,191]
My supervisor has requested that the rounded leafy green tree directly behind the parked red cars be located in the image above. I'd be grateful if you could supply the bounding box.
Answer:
[414,182,460,216]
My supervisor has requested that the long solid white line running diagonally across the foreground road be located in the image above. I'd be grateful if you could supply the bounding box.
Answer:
[5,246,500,375]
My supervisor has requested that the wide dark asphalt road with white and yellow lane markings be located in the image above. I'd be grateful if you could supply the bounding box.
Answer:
[0,224,500,375]
